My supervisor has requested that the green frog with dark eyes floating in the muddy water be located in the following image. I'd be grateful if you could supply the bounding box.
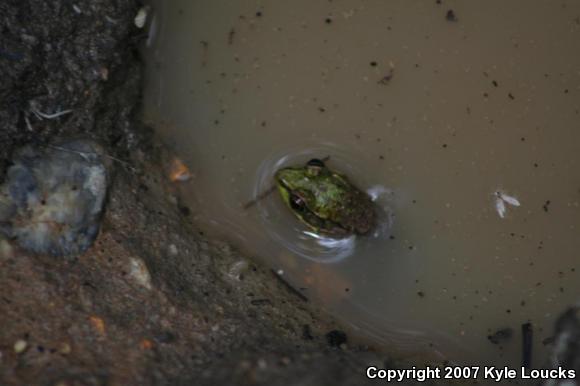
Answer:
[274,158,376,237]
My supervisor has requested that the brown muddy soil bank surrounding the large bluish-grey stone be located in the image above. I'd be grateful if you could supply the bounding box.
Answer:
[0,0,422,386]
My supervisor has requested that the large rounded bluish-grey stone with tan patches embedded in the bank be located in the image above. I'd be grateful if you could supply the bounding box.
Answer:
[0,140,107,256]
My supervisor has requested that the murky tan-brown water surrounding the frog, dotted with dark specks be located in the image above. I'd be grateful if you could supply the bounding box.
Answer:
[145,0,580,366]
